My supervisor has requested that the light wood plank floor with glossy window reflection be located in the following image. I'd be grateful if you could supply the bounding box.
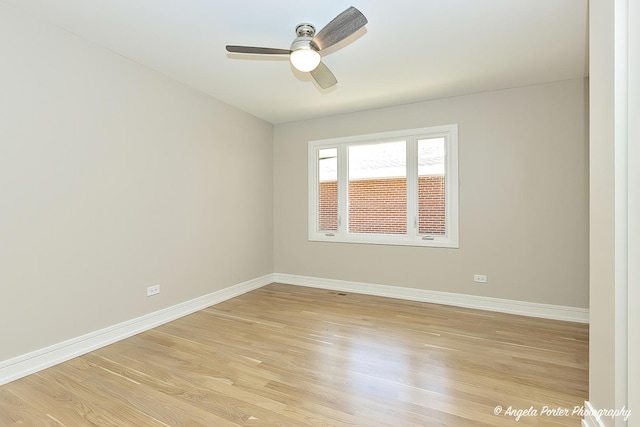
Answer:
[0,284,588,427]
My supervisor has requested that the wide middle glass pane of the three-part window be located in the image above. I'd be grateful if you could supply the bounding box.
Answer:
[349,141,407,234]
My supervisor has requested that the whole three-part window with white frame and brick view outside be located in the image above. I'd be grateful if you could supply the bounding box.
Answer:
[309,125,458,248]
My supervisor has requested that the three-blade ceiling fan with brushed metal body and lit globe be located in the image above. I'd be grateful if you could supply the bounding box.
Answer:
[227,6,368,89]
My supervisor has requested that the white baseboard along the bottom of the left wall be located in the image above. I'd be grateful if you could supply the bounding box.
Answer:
[0,274,273,385]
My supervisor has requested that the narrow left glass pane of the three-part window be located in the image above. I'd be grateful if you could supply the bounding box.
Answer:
[318,148,338,231]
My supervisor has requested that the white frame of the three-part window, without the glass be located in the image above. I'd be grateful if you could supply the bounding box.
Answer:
[308,124,459,248]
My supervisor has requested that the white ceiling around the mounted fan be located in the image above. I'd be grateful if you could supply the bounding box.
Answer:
[0,0,588,123]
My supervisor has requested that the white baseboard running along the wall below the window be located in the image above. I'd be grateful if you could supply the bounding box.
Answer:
[273,273,589,323]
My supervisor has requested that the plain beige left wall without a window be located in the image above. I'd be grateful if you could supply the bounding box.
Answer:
[0,3,273,361]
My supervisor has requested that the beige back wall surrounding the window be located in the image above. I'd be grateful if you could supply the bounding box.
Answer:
[274,79,589,308]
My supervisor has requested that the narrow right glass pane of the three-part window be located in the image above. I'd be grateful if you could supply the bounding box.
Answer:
[418,138,446,235]
